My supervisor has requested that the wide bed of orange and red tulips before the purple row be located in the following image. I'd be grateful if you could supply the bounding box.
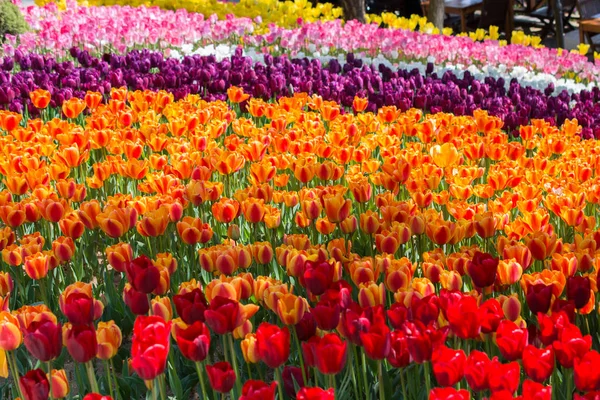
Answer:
[0,86,600,400]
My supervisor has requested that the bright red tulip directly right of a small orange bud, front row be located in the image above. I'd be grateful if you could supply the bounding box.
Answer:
[256,322,290,368]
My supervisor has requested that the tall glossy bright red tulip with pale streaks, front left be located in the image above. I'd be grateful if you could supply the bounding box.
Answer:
[131,315,171,381]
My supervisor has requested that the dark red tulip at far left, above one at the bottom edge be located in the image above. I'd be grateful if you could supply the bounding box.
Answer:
[23,319,62,362]
